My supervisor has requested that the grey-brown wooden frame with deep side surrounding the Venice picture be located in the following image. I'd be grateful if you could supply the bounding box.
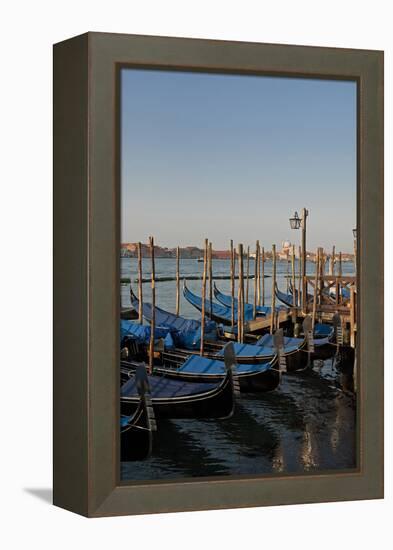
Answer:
[53,33,383,517]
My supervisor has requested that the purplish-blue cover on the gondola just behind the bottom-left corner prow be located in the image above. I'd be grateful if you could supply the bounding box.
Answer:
[120,374,219,399]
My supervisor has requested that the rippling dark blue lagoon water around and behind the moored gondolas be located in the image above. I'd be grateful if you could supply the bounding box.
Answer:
[121,258,356,480]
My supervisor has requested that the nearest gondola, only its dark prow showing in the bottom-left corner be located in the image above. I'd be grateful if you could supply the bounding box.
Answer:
[120,367,156,462]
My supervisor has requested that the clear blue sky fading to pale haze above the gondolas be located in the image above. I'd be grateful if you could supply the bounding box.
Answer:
[121,69,356,252]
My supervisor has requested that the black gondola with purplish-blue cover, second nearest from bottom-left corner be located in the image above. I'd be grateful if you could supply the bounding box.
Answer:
[120,342,238,419]
